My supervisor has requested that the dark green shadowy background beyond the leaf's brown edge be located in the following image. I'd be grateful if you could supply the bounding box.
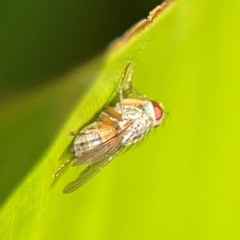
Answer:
[0,0,161,95]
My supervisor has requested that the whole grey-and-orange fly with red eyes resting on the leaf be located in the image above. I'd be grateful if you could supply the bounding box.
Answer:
[54,62,164,193]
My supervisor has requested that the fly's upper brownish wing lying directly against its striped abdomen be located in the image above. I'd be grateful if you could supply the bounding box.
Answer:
[72,120,133,166]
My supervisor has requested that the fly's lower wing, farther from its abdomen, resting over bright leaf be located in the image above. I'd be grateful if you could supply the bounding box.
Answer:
[63,146,123,193]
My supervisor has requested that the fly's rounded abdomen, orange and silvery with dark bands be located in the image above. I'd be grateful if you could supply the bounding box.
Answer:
[72,122,116,158]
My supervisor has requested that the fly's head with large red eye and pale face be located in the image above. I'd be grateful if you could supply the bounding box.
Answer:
[143,100,164,127]
